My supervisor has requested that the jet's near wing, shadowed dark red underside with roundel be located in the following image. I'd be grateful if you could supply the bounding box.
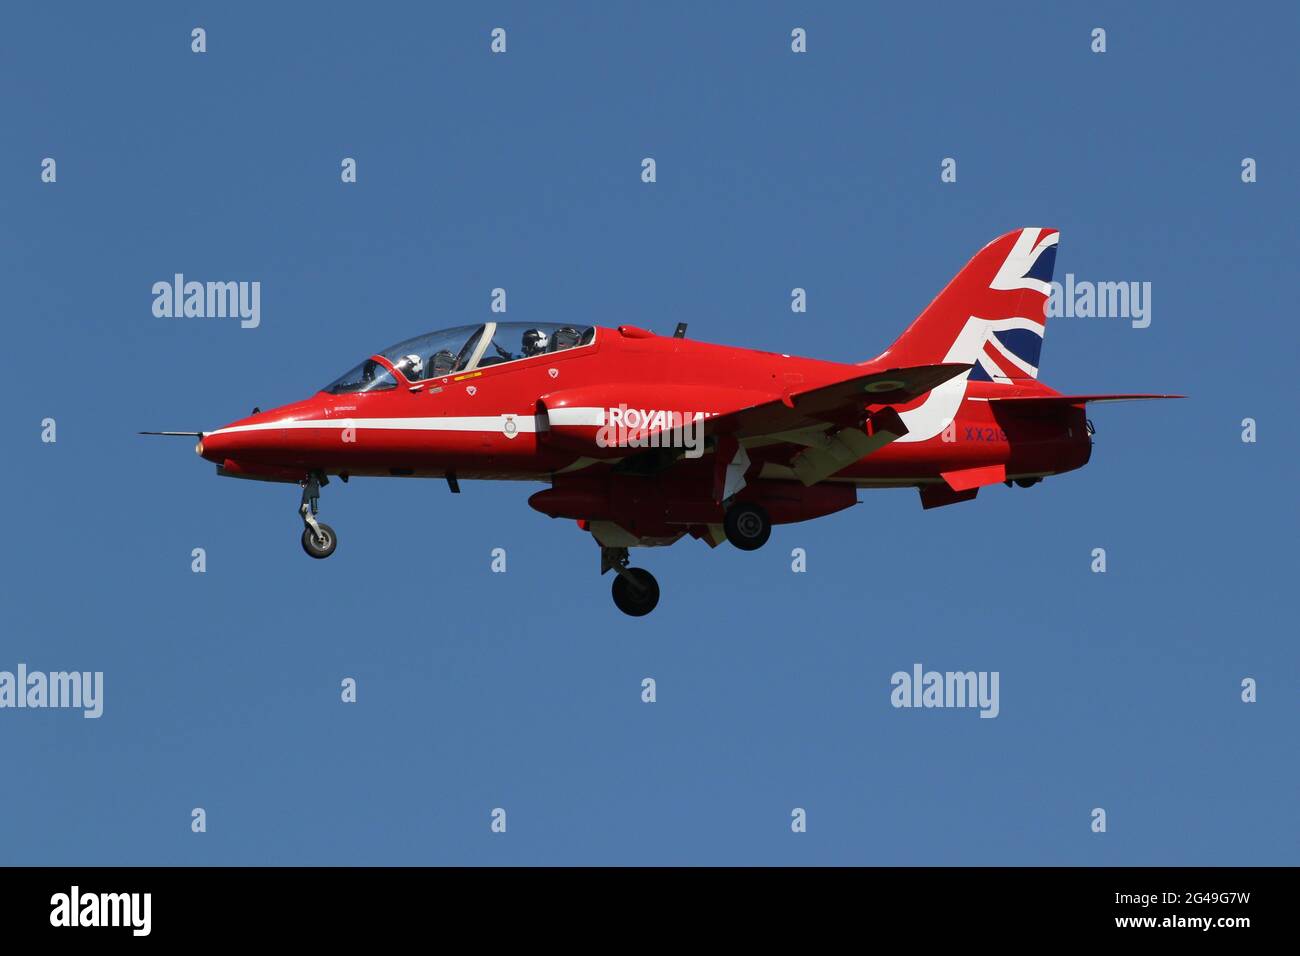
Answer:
[705,364,971,440]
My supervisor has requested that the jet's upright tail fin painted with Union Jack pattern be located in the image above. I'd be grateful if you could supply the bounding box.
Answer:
[863,226,1060,382]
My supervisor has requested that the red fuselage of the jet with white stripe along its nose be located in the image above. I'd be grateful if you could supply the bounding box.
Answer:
[200,326,1091,496]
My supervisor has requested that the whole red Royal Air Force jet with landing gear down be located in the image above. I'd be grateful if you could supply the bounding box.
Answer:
[148,228,1178,615]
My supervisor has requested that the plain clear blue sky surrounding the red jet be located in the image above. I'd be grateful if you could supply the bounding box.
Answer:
[0,3,1300,865]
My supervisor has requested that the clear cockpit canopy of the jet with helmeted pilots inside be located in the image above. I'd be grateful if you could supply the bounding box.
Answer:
[325,323,595,395]
